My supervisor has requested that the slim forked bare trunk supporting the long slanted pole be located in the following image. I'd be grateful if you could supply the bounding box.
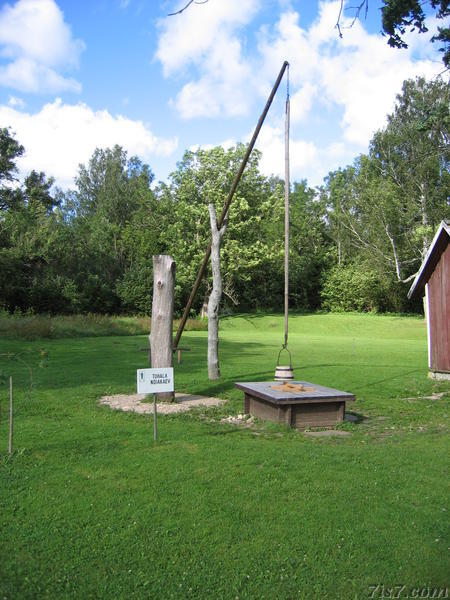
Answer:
[208,204,228,379]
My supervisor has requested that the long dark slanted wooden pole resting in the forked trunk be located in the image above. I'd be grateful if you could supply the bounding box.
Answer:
[173,61,289,348]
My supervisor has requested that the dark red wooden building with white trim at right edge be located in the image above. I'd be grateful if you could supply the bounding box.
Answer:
[408,221,450,379]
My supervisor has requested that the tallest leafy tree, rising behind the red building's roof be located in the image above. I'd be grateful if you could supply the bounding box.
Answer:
[370,78,450,262]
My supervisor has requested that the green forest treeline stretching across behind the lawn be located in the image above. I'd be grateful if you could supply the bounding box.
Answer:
[0,78,450,314]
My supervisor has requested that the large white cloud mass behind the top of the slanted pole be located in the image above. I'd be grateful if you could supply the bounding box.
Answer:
[155,0,442,185]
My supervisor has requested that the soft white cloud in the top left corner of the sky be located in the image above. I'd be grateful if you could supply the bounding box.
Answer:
[0,0,85,93]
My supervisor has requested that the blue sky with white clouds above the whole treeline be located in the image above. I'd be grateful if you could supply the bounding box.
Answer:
[0,0,443,188]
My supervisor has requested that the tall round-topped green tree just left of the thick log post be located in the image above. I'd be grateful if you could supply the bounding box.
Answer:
[70,146,155,312]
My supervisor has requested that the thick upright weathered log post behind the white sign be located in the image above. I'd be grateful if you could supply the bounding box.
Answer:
[150,254,175,402]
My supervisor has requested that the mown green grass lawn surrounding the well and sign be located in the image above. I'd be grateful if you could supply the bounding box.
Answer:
[0,314,450,600]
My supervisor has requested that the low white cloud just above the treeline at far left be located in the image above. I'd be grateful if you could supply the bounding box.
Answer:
[0,99,178,188]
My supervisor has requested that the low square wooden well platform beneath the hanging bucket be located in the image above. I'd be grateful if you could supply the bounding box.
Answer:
[235,381,355,429]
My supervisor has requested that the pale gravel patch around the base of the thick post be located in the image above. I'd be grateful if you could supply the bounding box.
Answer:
[100,392,226,415]
